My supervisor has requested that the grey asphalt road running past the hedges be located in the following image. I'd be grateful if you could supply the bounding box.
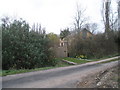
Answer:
[2,57,118,88]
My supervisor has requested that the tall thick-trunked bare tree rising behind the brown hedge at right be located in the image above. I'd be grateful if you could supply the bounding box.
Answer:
[102,0,119,35]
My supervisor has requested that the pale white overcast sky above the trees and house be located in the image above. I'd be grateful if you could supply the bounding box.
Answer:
[0,0,117,34]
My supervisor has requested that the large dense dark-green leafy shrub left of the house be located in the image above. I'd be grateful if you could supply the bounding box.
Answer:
[2,19,55,69]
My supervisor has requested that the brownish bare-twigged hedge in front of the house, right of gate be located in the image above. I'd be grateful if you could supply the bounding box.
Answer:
[69,31,118,58]
